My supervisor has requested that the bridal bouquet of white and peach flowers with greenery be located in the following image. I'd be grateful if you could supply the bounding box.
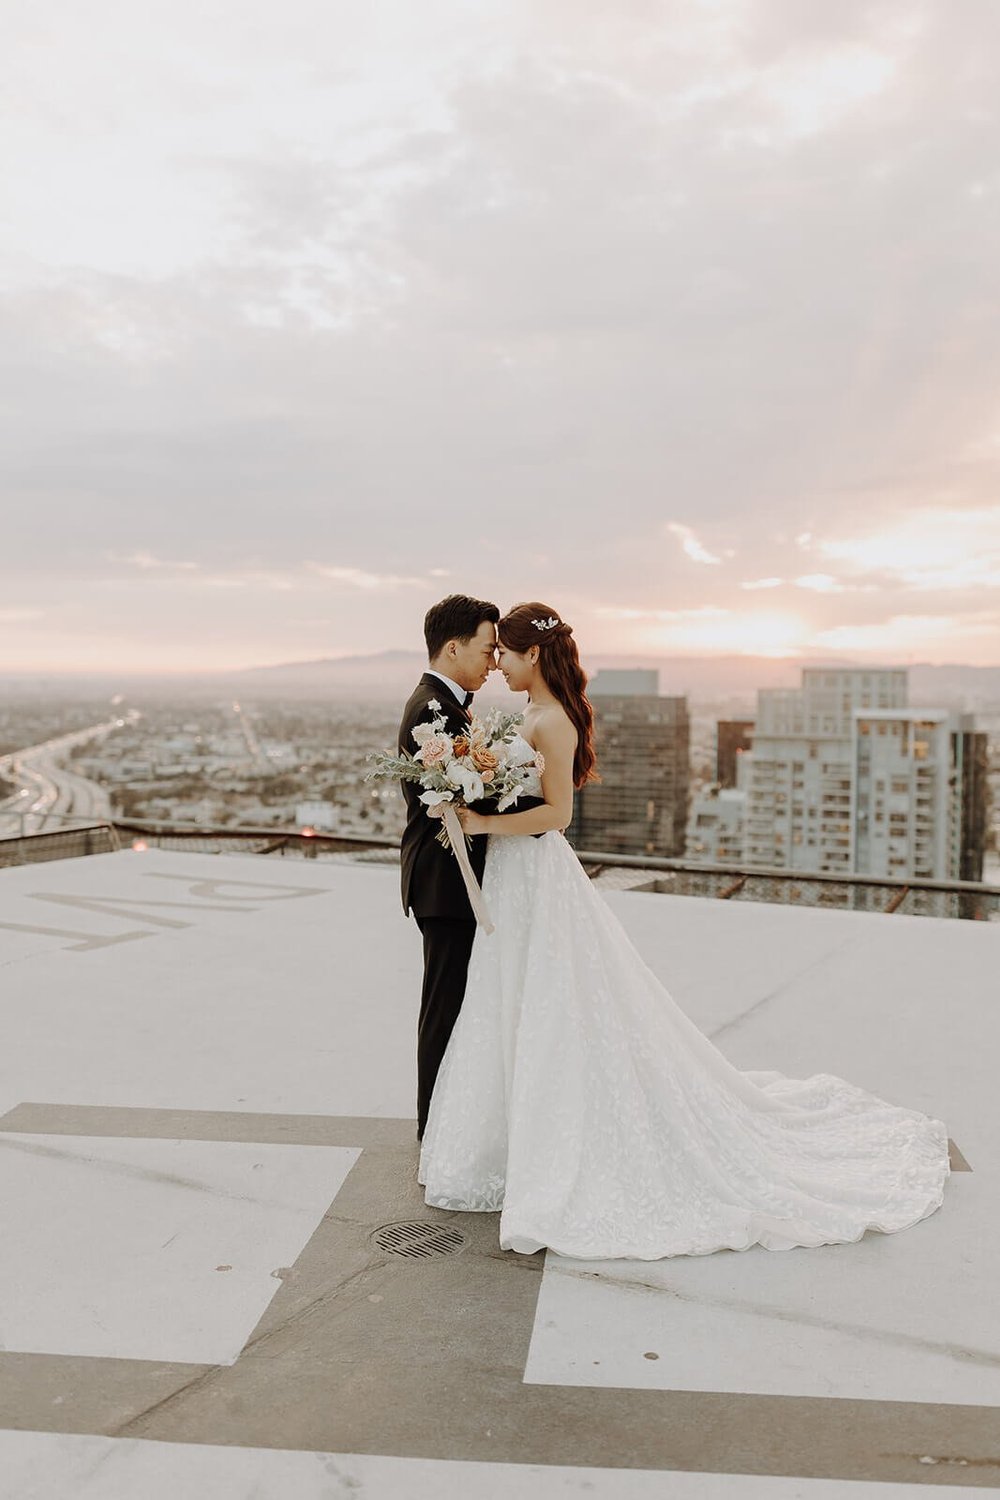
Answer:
[364,698,544,849]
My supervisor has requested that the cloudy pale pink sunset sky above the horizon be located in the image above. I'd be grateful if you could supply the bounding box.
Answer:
[0,0,1000,672]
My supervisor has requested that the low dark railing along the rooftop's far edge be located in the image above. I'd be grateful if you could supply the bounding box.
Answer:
[0,819,1000,921]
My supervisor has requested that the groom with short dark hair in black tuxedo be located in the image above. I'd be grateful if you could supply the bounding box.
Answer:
[399,594,499,1140]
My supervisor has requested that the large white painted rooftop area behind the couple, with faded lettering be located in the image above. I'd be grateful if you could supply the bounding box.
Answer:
[0,851,983,1140]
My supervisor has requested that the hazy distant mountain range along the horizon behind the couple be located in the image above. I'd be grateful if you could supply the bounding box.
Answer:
[0,651,1000,710]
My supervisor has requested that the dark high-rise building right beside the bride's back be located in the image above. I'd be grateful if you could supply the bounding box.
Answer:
[568,671,691,855]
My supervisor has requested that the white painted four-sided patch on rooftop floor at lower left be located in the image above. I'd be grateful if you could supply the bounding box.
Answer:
[0,1134,358,1365]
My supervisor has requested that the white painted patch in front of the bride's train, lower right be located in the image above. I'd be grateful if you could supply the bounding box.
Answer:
[525,1173,1000,1406]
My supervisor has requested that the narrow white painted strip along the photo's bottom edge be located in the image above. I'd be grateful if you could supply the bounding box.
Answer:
[0,1433,969,1500]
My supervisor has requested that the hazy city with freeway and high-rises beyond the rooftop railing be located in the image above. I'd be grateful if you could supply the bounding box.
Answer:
[0,668,1000,882]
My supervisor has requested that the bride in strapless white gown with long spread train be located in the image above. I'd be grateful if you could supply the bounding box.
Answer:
[417,603,949,1260]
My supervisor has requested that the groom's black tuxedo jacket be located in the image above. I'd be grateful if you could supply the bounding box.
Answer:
[399,672,486,921]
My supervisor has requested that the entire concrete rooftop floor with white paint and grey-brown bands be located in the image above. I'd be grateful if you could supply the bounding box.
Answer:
[0,851,1000,1500]
